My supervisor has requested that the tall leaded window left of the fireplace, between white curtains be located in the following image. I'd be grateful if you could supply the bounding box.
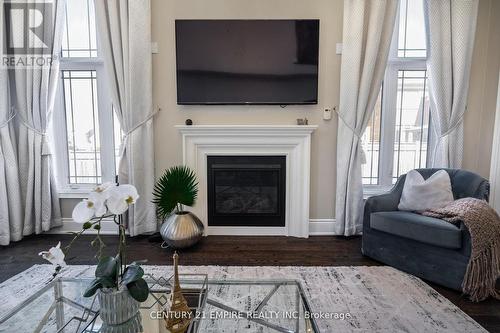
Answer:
[54,0,120,194]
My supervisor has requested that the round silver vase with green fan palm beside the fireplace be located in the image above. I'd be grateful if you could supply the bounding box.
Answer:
[153,166,204,248]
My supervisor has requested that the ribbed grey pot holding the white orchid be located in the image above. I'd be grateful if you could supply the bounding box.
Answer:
[98,289,142,333]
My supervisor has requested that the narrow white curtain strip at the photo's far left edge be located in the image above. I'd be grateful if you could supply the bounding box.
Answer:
[0,6,23,245]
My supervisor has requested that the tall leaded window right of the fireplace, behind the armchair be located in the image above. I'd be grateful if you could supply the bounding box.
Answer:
[361,0,430,192]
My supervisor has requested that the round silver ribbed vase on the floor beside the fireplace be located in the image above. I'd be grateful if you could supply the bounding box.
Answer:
[160,212,205,249]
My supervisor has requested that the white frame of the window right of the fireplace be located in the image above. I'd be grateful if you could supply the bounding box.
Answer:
[363,6,433,196]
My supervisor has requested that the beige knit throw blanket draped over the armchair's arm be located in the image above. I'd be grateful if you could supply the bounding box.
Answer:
[422,198,500,302]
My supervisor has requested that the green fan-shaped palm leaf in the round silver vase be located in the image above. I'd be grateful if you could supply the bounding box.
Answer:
[153,165,198,219]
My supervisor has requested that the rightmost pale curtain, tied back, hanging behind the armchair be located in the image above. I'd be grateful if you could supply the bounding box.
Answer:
[425,0,479,168]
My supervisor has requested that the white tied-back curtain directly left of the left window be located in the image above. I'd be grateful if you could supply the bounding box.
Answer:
[4,0,65,240]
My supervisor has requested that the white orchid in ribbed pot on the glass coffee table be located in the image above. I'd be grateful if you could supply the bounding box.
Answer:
[40,183,149,333]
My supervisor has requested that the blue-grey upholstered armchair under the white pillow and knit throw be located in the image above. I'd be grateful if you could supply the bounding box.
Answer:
[362,169,489,290]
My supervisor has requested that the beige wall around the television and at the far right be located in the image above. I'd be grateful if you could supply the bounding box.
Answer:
[63,0,500,219]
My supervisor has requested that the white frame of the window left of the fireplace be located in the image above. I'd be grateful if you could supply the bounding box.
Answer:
[53,17,116,198]
